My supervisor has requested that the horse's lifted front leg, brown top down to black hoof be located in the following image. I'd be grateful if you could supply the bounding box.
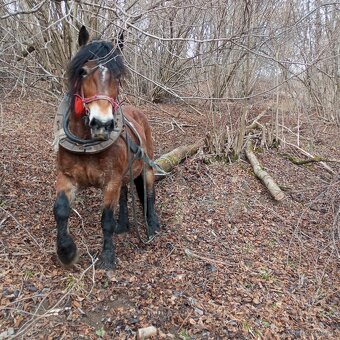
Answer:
[53,174,78,266]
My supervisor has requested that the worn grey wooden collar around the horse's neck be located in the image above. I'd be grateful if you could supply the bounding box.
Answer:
[53,94,124,154]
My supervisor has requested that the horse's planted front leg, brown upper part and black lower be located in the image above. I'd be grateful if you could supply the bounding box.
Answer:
[98,180,121,270]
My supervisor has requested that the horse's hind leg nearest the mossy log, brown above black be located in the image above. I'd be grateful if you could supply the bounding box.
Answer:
[134,167,160,238]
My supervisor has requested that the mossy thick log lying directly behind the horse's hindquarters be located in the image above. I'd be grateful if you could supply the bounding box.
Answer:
[155,140,204,180]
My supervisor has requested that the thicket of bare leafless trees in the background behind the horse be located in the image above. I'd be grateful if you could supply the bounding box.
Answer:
[0,0,340,123]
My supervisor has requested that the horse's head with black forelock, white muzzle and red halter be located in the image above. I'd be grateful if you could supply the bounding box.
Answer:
[68,26,125,140]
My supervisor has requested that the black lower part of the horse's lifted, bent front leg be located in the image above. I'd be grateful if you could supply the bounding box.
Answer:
[53,192,77,265]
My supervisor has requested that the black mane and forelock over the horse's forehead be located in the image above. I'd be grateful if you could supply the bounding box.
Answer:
[67,40,126,94]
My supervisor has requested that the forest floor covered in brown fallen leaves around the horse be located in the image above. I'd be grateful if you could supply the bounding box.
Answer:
[0,93,340,340]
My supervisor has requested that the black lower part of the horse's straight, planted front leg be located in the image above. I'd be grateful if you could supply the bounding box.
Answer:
[99,208,116,269]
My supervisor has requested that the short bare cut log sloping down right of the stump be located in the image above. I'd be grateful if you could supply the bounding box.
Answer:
[245,140,285,201]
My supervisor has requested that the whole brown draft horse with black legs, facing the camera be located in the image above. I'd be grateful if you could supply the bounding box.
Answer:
[54,26,159,269]
